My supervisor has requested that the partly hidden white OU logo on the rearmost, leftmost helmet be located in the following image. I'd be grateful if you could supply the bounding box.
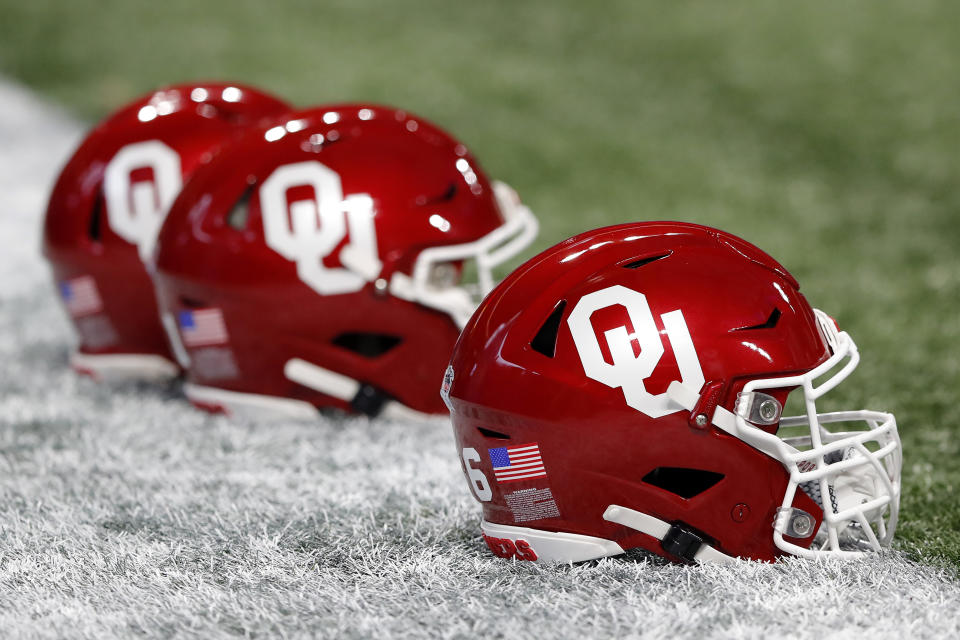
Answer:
[103,140,183,261]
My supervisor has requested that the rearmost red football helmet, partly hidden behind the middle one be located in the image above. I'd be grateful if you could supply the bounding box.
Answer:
[43,84,289,379]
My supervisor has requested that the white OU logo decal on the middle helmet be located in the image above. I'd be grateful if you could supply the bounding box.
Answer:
[260,160,383,295]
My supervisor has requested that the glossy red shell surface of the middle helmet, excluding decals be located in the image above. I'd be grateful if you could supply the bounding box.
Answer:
[157,104,503,413]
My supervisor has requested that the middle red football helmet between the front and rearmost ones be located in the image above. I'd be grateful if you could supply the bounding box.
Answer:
[157,104,537,417]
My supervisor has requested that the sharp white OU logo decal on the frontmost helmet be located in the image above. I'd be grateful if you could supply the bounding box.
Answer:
[567,285,704,418]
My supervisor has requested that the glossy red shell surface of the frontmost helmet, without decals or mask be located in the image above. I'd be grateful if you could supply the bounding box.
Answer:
[450,222,829,560]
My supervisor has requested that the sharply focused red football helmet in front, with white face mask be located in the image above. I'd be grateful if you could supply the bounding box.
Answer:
[441,222,901,562]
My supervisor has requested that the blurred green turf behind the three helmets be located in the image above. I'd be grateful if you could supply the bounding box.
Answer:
[0,0,960,565]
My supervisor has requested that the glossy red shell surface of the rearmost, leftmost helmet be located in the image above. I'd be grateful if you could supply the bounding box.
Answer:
[43,83,289,368]
